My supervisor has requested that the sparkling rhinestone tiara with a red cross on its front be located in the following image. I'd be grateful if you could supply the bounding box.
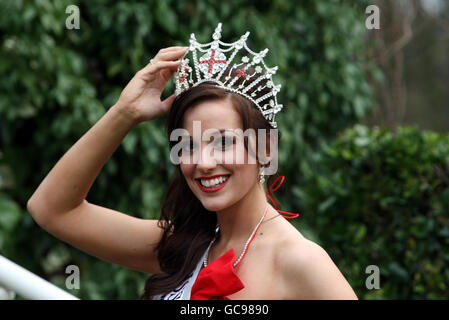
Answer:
[173,23,283,128]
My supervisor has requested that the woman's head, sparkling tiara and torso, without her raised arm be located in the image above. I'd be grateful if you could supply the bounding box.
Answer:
[142,24,357,300]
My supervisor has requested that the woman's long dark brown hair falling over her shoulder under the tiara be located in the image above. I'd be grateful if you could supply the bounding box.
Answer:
[141,68,281,299]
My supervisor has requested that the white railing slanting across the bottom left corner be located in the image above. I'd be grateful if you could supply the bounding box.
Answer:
[0,255,79,300]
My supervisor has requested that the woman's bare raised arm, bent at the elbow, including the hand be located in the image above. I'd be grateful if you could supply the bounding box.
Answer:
[27,47,186,273]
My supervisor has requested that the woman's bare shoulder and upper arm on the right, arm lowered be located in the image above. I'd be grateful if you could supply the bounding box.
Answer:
[277,226,357,299]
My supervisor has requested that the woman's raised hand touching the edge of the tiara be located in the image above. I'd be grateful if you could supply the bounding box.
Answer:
[116,47,188,122]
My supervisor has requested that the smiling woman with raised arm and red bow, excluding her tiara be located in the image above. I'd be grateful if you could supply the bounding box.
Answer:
[27,25,357,299]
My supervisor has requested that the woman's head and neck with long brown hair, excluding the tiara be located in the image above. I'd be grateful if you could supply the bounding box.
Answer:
[143,75,286,298]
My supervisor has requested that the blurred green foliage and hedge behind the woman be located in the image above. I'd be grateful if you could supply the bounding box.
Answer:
[0,0,449,299]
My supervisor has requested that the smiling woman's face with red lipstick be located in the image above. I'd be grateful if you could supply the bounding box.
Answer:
[180,99,259,211]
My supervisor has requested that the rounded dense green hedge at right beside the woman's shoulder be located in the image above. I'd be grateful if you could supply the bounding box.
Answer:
[297,125,449,299]
